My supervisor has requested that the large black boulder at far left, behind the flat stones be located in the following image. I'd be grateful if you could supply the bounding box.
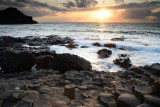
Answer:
[1,52,35,73]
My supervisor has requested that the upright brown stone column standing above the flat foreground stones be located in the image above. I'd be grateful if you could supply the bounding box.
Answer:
[64,84,75,99]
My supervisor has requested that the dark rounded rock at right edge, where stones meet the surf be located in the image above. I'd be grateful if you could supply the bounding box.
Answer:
[151,63,160,76]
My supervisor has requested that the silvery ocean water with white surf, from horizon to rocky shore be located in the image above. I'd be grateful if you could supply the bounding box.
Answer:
[0,22,160,72]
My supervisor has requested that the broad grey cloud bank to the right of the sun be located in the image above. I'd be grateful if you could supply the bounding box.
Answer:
[106,1,160,21]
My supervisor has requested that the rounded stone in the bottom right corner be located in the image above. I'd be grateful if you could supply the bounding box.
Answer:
[144,94,160,107]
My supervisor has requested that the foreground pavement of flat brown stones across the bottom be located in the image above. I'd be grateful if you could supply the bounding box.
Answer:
[0,64,160,107]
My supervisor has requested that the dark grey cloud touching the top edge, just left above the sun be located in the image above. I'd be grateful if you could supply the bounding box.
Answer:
[64,0,98,8]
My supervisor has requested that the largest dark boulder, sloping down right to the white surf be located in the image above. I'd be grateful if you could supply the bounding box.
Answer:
[53,54,92,73]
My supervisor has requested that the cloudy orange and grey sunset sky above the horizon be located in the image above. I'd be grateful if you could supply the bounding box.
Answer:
[0,0,160,22]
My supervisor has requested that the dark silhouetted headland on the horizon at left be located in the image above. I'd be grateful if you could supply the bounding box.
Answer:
[0,7,37,24]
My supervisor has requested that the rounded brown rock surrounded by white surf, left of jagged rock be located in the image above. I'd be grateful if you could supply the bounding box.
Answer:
[97,49,112,58]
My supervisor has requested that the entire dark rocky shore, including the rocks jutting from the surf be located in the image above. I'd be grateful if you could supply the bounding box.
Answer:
[0,35,160,107]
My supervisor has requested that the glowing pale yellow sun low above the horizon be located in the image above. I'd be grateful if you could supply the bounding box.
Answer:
[93,9,112,21]
